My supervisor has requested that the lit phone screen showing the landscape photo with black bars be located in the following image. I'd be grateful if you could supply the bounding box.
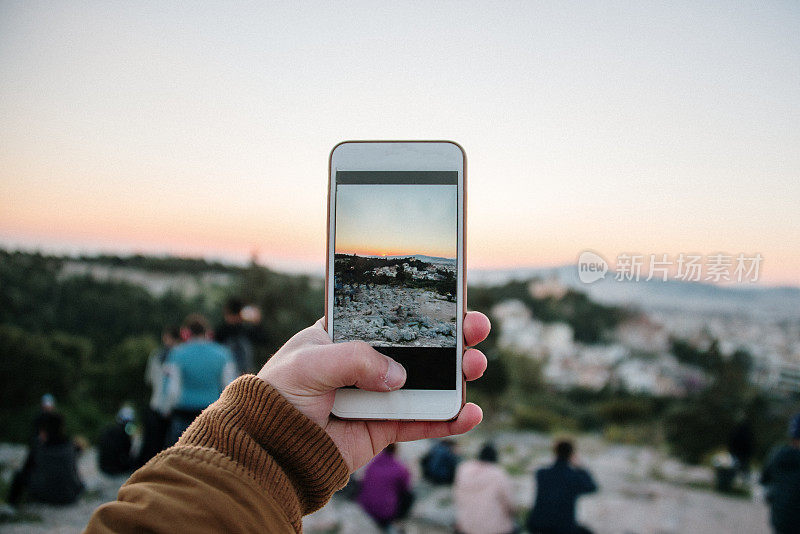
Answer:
[333,170,459,390]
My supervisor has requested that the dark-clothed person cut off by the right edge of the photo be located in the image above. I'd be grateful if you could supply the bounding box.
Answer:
[761,413,800,534]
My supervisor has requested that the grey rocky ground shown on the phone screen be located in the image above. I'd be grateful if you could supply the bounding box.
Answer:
[333,285,456,347]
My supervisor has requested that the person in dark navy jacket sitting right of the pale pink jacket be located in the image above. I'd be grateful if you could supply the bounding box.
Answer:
[527,440,597,534]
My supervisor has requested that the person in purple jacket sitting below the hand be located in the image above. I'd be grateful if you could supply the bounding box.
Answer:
[357,443,412,530]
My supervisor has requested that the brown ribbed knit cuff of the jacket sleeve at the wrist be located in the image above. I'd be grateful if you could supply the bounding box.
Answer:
[178,375,349,531]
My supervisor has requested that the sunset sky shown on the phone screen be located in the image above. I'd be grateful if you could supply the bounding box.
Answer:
[336,184,458,258]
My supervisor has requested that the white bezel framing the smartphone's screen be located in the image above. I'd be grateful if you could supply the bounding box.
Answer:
[325,141,467,421]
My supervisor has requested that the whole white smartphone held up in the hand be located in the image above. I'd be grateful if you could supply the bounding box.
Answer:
[325,141,466,421]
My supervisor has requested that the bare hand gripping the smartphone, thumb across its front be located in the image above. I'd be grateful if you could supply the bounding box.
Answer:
[258,312,490,472]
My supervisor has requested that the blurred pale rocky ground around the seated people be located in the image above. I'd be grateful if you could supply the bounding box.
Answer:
[0,433,769,534]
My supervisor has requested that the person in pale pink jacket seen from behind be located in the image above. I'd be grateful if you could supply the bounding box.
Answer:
[453,443,516,534]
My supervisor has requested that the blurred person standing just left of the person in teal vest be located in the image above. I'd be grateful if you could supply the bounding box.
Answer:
[136,326,181,466]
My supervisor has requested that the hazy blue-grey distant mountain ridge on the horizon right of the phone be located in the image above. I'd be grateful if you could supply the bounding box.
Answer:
[467,265,800,319]
